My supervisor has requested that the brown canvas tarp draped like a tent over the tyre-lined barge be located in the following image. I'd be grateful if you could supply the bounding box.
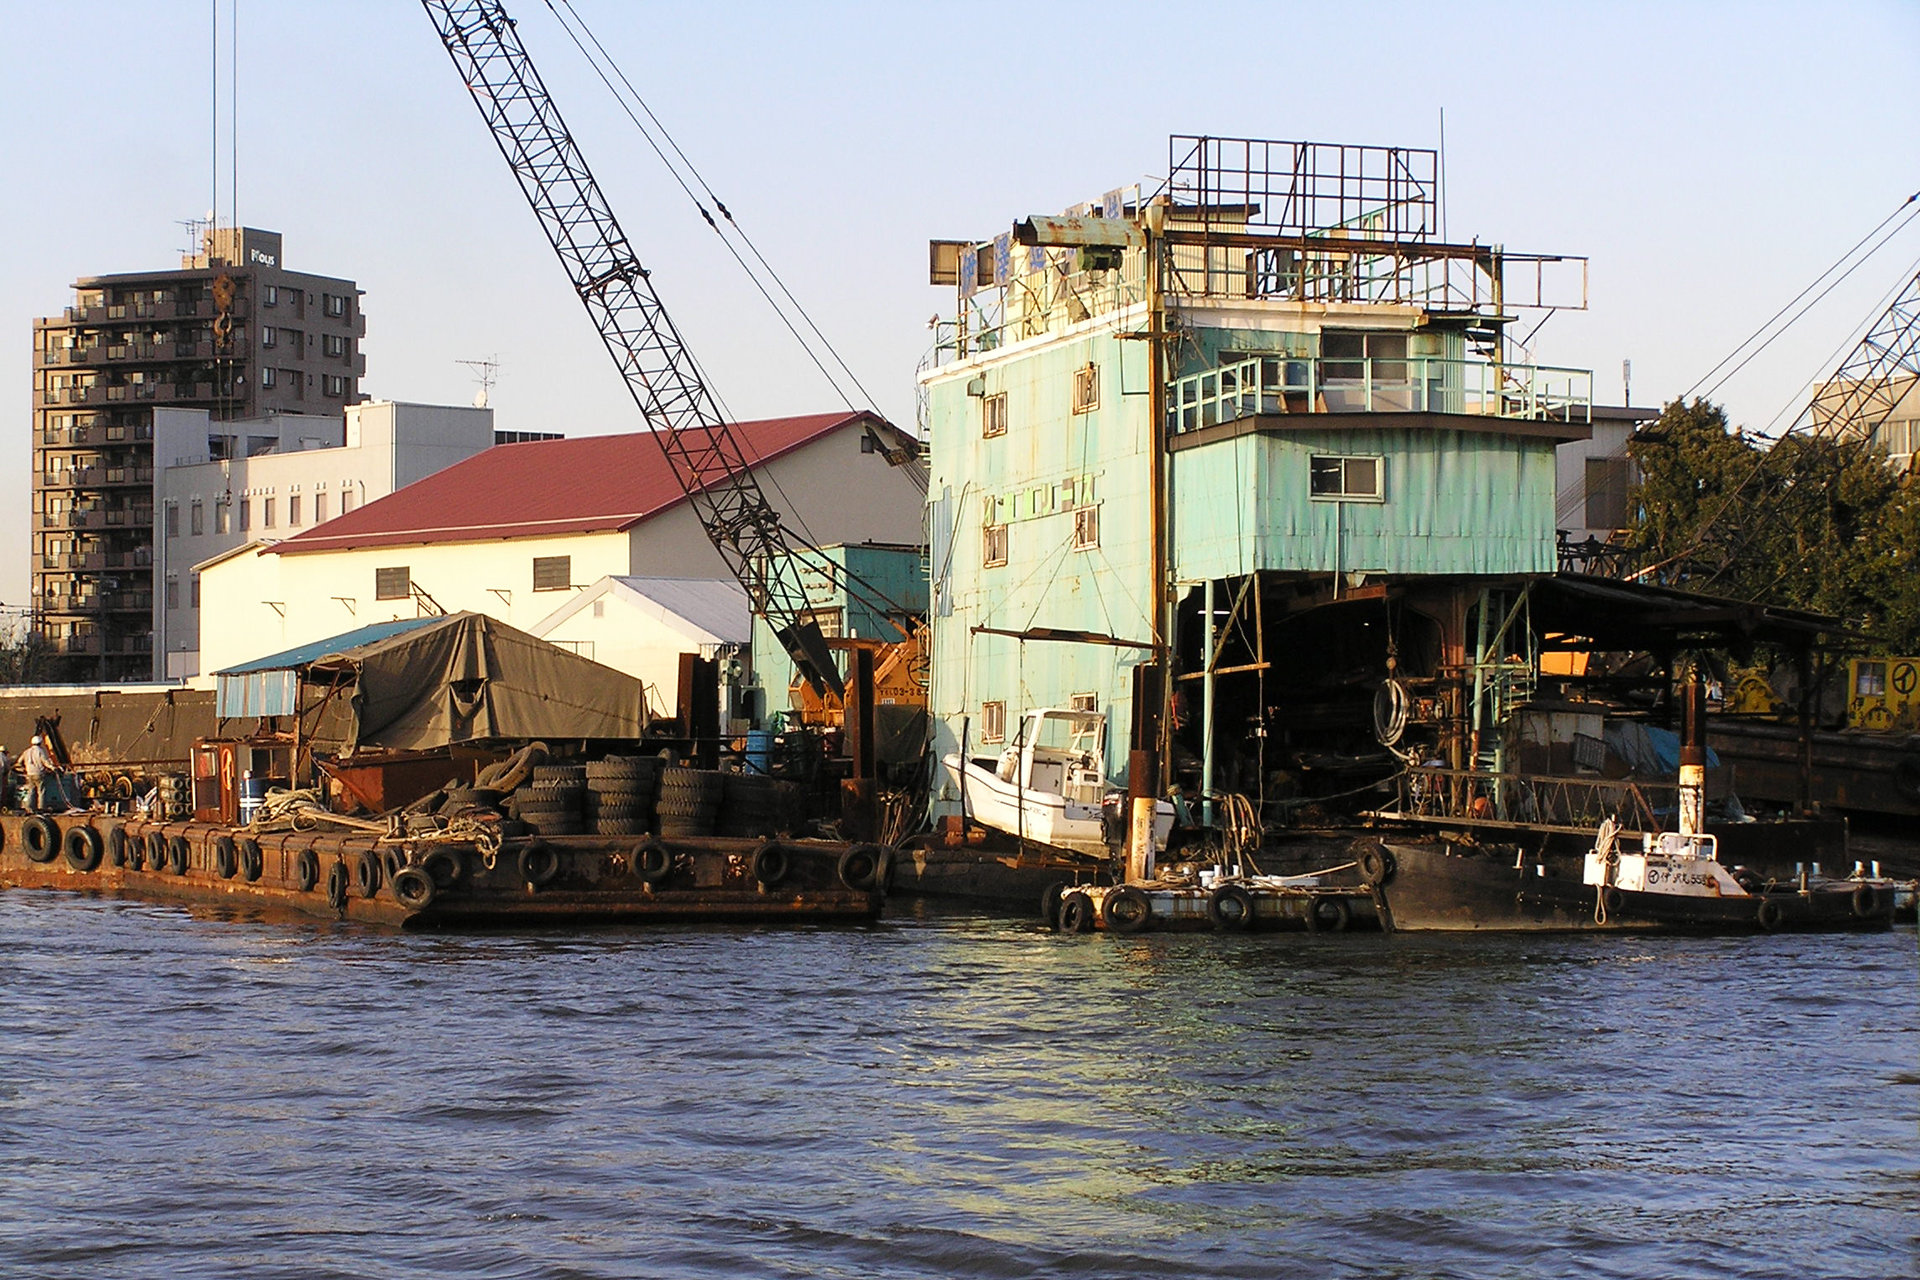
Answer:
[219,612,645,750]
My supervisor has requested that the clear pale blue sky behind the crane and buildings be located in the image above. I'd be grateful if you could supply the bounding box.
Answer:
[0,0,1920,604]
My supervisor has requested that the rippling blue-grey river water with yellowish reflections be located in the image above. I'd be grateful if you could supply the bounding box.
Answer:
[0,892,1920,1280]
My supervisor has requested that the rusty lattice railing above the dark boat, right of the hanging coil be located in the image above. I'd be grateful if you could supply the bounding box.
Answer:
[1377,766,1680,835]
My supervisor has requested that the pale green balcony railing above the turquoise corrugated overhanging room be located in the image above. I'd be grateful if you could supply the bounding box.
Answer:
[1167,355,1594,436]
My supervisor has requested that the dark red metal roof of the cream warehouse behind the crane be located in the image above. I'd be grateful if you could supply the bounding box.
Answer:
[269,413,891,555]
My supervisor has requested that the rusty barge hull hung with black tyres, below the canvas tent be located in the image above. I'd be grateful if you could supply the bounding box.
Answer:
[0,814,885,931]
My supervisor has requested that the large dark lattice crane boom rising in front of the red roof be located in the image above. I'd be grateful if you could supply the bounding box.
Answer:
[420,0,841,693]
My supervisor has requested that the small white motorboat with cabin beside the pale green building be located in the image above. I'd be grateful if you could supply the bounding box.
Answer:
[943,706,1173,856]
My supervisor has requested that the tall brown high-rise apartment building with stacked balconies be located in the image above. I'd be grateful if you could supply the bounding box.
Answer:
[33,228,367,681]
